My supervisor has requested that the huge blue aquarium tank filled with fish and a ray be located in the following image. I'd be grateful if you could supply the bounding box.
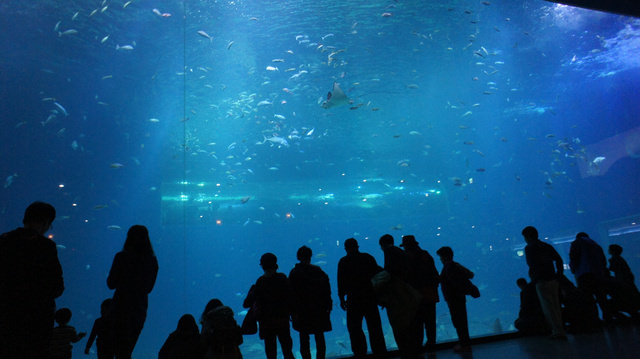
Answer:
[0,0,640,358]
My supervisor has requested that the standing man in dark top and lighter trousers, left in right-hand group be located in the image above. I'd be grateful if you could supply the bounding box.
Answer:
[522,226,567,340]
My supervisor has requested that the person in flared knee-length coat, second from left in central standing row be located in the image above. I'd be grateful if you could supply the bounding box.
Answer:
[289,246,333,359]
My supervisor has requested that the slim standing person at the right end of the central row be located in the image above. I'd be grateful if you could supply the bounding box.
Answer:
[436,247,473,353]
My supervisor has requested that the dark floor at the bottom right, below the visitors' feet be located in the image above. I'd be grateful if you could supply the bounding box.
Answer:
[380,324,640,359]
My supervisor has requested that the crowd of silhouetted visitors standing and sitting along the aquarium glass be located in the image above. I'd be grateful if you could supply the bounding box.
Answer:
[0,202,640,359]
